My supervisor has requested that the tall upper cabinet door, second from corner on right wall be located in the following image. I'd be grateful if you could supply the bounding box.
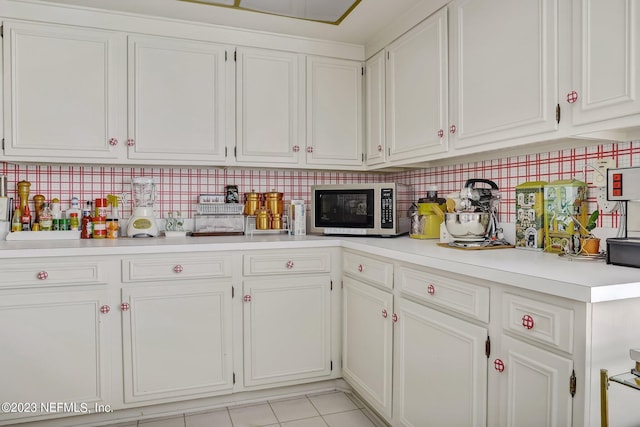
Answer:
[386,8,449,160]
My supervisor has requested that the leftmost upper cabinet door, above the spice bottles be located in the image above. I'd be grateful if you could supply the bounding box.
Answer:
[3,22,126,162]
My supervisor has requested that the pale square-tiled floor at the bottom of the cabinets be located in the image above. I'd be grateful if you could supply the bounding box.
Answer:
[106,391,380,427]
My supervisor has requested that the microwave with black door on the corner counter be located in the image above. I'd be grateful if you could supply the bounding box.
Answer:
[310,183,414,236]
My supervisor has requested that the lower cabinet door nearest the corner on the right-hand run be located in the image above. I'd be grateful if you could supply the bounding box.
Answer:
[342,277,393,420]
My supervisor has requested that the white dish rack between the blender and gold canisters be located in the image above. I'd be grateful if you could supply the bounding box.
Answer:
[192,203,245,236]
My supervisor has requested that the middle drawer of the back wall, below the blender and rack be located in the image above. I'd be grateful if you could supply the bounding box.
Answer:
[122,254,231,282]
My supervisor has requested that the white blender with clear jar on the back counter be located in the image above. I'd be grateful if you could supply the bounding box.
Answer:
[127,177,158,237]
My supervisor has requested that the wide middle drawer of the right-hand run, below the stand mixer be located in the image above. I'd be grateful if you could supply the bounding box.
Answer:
[397,266,490,322]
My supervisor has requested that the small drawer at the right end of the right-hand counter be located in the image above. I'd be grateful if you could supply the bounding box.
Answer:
[502,293,574,353]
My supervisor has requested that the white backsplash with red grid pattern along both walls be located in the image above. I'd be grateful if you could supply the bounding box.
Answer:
[0,141,640,228]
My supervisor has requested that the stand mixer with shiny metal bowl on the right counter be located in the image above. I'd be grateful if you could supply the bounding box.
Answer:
[445,179,509,247]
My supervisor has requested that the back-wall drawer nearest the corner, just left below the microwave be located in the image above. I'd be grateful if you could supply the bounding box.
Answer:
[243,250,331,276]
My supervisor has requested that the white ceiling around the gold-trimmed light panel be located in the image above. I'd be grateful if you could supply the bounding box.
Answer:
[32,0,442,45]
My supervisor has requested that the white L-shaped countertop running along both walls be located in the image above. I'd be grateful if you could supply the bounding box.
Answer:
[0,234,640,302]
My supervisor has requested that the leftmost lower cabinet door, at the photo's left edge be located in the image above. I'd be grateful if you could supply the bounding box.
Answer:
[0,287,111,423]
